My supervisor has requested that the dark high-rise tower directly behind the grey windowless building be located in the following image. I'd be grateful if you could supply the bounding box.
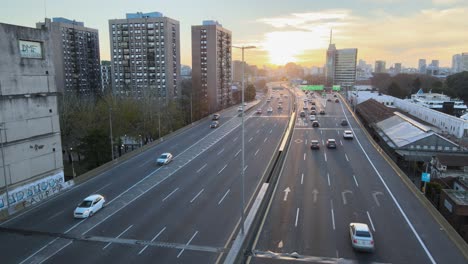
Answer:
[36,17,102,96]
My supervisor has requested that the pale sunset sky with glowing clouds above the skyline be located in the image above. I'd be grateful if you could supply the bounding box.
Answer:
[0,0,468,67]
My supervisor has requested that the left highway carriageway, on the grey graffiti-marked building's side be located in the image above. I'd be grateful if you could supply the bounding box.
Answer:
[0,83,291,263]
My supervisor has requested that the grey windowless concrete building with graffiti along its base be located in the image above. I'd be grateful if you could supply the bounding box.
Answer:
[0,24,64,213]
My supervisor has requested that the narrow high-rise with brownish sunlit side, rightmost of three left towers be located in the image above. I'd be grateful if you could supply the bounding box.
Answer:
[192,20,232,116]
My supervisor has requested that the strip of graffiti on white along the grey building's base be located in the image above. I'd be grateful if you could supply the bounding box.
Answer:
[0,172,68,210]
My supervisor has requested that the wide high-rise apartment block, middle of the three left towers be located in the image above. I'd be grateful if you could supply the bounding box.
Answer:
[109,12,181,100]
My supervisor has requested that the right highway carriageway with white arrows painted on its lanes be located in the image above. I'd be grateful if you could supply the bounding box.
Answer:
[248,87,467,264]
